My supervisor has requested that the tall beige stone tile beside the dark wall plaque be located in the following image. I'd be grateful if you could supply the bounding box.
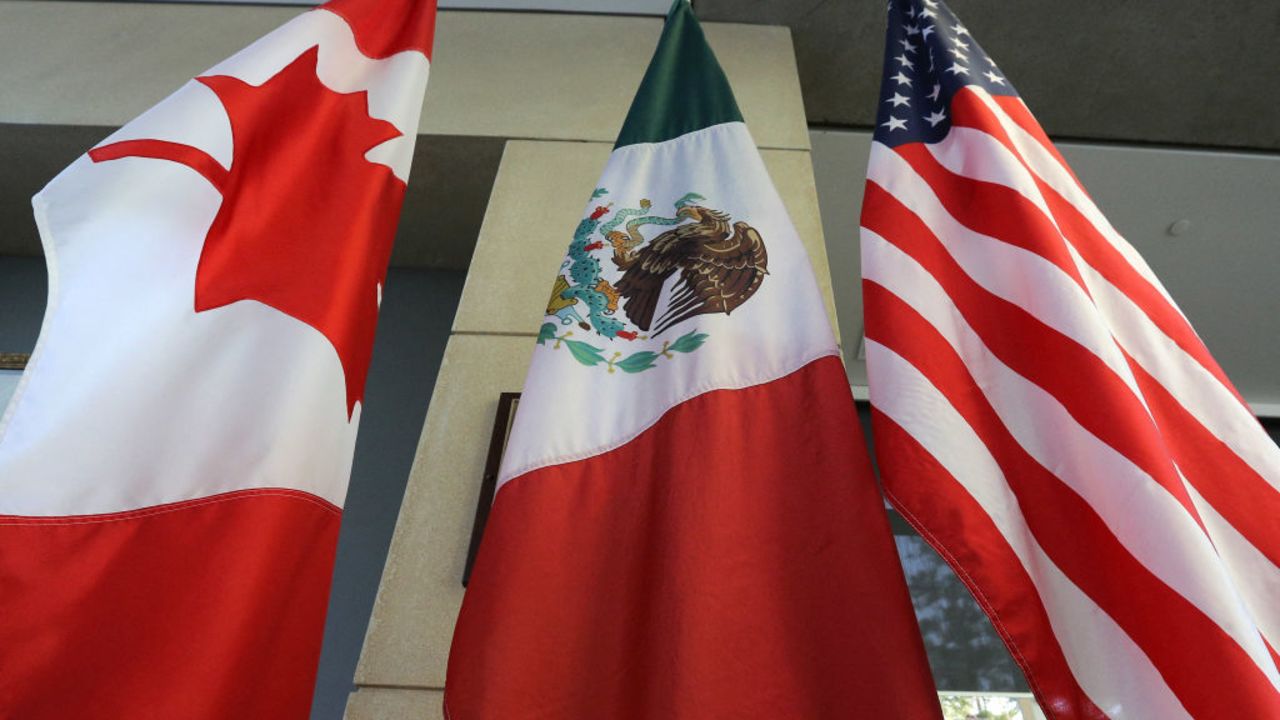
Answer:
[356,334,534,688]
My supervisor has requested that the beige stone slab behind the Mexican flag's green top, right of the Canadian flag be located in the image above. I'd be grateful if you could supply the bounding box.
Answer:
[422,13,809,149]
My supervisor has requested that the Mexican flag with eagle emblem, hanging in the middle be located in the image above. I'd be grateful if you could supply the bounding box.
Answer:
[444,0,940,720]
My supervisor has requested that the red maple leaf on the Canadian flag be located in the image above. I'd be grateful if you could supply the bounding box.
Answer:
[90,47,406,418]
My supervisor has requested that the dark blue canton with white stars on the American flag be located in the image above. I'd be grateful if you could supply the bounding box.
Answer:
[876,0,1018,146]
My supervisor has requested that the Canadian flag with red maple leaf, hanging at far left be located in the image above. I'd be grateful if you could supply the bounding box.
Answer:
[0,0,435,720]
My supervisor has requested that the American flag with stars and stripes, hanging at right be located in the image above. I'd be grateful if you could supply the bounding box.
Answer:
[861,0,1280,720]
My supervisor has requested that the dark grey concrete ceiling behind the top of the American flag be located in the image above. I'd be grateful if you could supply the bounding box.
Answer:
[694,0,1280,151]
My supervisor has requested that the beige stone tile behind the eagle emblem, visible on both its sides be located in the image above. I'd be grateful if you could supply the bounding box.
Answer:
[453,141,836,345]
